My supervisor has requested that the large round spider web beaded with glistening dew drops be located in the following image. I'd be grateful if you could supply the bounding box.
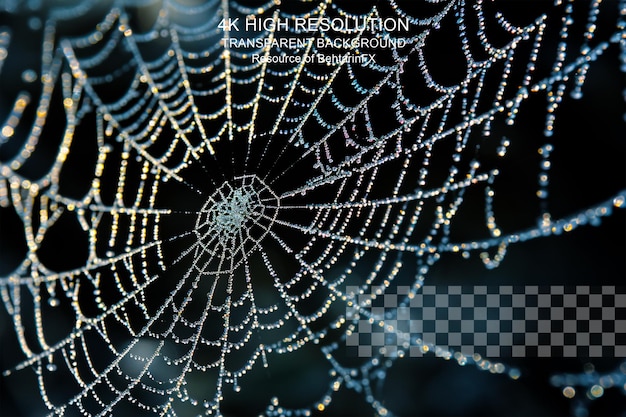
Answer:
[0,0,626,415]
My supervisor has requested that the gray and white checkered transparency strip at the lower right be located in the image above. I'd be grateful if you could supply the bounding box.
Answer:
[346,285,626,358]
